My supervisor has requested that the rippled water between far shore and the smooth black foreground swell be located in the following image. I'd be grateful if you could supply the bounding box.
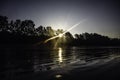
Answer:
[0,47,120,80]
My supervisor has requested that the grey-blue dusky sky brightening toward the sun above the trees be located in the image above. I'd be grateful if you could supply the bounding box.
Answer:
[0,0,120,38]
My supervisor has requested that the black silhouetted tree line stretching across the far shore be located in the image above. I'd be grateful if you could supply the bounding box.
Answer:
[0,16,120,46]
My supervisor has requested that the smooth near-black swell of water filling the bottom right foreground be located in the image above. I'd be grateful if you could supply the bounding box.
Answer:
[15,59,120,80]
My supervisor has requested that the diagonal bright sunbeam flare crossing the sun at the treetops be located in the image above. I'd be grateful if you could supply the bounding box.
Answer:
[44,19,86,43]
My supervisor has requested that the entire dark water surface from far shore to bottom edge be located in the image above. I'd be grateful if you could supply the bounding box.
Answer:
[0,47,120,80]
